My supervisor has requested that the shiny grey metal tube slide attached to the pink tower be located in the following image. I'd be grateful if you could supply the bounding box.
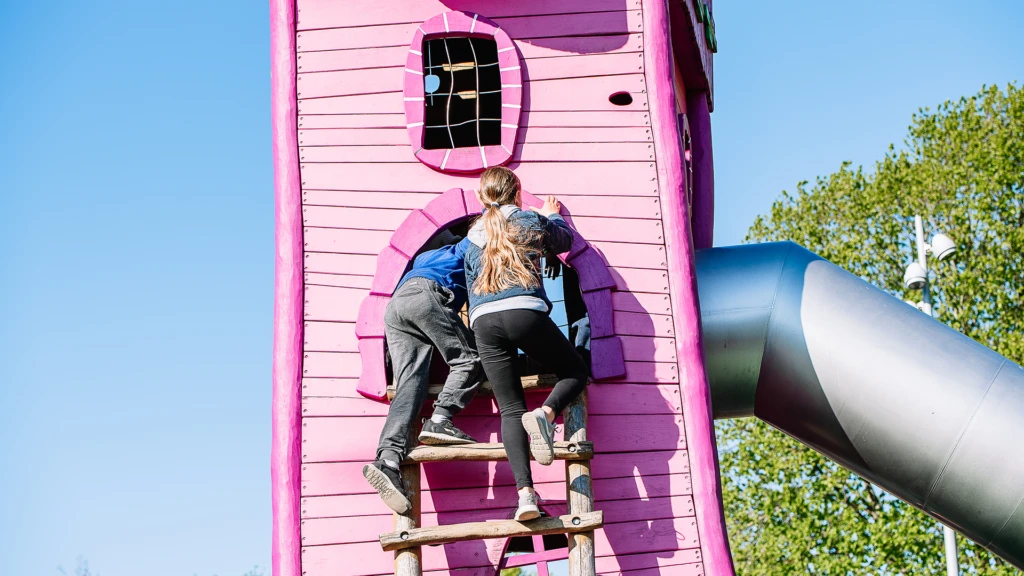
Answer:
[696,242,1024,569]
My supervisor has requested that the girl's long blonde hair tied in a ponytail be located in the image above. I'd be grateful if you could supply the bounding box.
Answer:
[473,166,541,294]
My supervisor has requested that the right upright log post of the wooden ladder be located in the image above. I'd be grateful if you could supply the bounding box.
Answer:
[562,389,597,576]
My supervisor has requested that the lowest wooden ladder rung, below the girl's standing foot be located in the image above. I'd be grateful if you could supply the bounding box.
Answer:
[381,510,604,550]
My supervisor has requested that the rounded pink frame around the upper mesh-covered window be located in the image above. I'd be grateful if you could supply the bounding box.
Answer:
[403,11,523,173]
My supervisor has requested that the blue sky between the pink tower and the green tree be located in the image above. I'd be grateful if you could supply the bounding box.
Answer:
[712,0,1024,245]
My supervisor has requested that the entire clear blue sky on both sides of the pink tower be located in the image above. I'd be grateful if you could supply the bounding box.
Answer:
[0,0,1024,576]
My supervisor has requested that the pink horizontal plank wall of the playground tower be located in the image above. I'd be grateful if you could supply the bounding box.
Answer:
[288,0,720,576]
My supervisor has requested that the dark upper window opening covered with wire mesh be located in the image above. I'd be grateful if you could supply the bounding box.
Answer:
[423,37,502,150]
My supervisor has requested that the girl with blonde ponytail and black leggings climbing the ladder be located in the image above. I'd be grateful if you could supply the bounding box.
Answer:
[466,167,588,520]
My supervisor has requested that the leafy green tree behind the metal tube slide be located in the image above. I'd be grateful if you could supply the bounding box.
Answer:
[717,84,1024,576]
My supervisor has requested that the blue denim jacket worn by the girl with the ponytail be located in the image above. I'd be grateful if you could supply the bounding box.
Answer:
[466,205,572,326]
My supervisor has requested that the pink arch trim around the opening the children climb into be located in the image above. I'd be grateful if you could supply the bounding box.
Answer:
[355,188,626,400]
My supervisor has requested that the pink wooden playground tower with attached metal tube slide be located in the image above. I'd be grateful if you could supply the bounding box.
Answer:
[270,0,1024,576]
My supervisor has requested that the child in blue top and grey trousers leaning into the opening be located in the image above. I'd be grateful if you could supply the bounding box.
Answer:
[362,232,480,513]
